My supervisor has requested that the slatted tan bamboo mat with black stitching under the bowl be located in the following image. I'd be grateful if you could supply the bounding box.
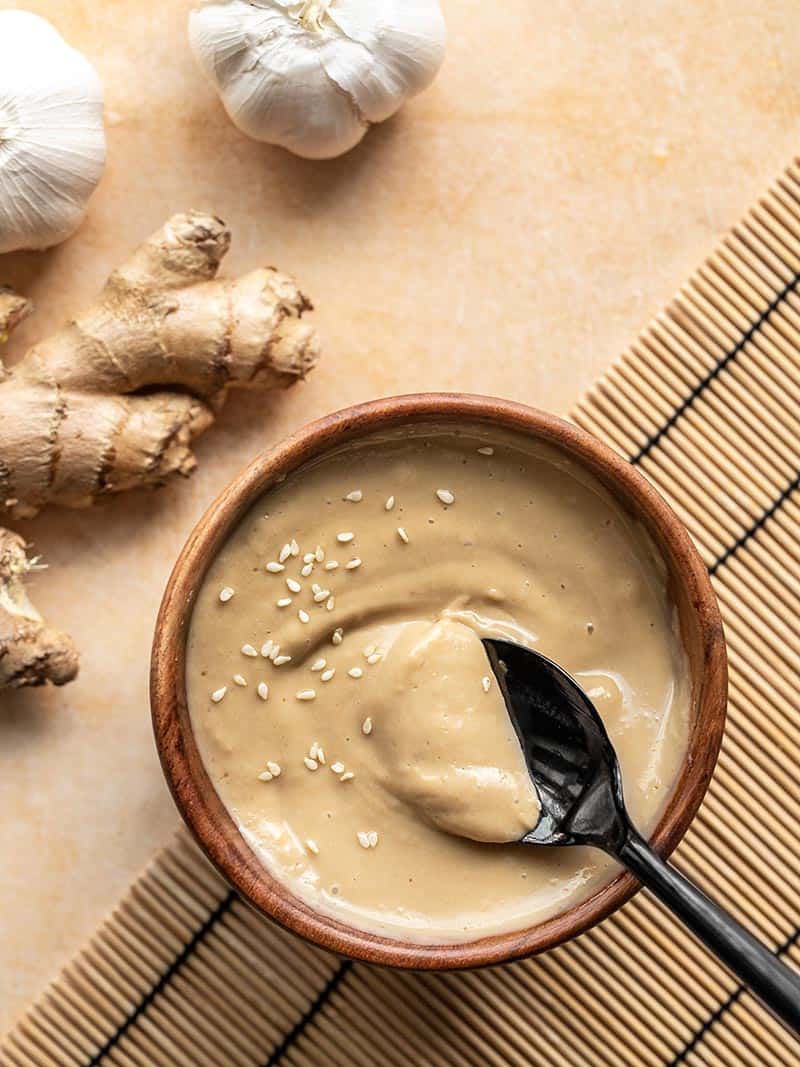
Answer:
[0,157,800,1067]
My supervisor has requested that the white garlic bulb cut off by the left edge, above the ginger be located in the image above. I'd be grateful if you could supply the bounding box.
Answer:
[0,11,106,253]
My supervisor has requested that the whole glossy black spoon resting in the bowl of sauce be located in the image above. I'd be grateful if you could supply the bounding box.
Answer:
[483,638,800,1037]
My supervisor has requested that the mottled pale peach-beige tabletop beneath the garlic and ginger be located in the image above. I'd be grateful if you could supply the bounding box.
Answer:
[0,0,800,1030]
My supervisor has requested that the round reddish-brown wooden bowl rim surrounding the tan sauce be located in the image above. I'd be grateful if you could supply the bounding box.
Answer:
[150,394,727,970]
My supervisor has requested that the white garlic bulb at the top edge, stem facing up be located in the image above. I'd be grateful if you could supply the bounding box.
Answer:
[189,0,445,159]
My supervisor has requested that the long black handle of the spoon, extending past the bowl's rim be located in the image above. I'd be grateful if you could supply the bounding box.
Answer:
[615,829,800,1037]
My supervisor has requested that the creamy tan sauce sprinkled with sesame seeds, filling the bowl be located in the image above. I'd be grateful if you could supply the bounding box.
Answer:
[187,427,688,942]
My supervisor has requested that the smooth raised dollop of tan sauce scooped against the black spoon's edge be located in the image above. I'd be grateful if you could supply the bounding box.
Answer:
[375,619,540,842]
